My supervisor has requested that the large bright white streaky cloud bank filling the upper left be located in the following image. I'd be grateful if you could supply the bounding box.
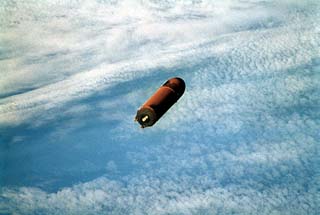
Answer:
[0,1,290,125]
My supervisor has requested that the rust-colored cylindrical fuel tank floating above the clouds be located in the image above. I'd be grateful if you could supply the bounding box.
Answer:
[135,77,186,128]
